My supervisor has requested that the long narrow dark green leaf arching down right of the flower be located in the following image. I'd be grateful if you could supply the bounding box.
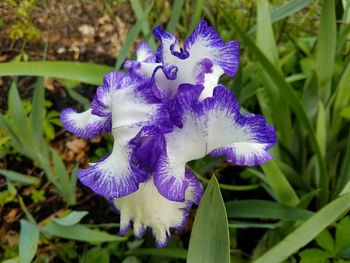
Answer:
[222,9,329,205]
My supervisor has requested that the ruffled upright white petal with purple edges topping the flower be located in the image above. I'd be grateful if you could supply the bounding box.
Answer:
[149,20,239,99]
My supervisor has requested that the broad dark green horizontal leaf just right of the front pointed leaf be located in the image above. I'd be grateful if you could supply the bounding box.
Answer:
[225,200,313,221]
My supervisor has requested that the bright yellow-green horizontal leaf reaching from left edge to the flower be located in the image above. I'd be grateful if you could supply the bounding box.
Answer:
[0,61,114,85]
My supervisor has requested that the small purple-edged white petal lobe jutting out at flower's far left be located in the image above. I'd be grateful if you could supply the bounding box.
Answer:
[60,108,112,138]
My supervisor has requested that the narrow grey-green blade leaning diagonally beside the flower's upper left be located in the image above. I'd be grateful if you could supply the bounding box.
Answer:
[115,4,153,70]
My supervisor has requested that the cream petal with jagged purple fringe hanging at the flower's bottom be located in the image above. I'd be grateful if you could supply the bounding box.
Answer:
[113,174,203,247]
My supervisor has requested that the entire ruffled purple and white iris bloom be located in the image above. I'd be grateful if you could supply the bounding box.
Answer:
[61,21,276,247]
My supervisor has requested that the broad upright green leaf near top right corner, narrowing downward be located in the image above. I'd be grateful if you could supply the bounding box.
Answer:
[316,0,337,103]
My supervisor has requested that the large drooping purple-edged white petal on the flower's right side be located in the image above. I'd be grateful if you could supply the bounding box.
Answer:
[149,85,276,202]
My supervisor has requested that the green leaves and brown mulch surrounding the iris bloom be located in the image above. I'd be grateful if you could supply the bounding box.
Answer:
[0,0,350,263]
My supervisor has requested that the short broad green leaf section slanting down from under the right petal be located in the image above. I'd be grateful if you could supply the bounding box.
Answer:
[261,161,299,206]
